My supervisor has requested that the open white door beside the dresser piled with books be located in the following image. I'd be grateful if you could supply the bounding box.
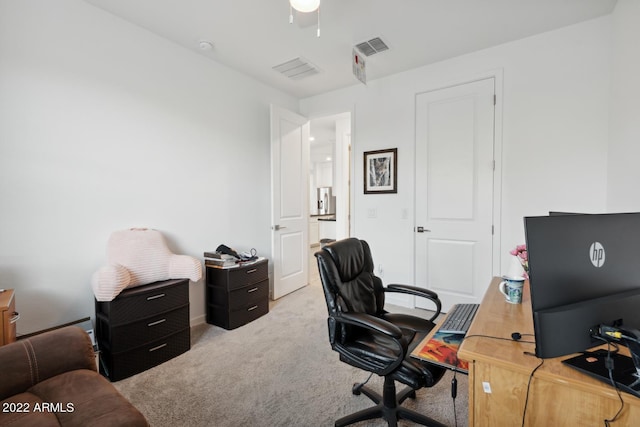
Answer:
[271,105,309,299]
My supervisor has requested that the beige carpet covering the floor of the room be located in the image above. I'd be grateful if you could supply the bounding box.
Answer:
[114,274,468,427]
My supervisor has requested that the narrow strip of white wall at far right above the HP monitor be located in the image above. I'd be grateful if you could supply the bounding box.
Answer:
[607,0,640,212]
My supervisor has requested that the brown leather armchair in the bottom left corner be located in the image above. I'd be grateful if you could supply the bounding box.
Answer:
[0,326,149,427]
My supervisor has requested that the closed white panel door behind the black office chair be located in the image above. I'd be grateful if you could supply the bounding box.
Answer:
[415,78,495,312]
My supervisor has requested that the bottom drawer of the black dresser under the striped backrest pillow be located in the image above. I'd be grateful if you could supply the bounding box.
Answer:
[100,328,191,381]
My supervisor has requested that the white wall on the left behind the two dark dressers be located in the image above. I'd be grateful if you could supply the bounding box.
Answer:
[0,0,298,334]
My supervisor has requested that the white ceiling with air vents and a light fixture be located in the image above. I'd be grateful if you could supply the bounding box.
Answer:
[85,0,616,98]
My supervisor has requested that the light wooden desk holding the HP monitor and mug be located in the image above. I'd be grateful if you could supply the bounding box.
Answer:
[458,277,640,427]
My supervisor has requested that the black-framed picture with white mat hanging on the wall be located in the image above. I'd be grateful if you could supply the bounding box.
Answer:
[364,148,398,194]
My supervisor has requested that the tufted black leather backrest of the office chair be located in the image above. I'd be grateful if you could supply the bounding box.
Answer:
[316,238,384,316]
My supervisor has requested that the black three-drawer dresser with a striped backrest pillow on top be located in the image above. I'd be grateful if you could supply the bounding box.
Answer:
[96,279,191,381]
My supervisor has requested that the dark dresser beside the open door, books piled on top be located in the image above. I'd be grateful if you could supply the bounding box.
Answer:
[206,258,269,329]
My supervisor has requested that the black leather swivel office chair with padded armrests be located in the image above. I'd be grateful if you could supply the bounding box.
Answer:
[315,238,445,426]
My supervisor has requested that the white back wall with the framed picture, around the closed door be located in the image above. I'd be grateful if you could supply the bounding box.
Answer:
[300,17,611,304]
